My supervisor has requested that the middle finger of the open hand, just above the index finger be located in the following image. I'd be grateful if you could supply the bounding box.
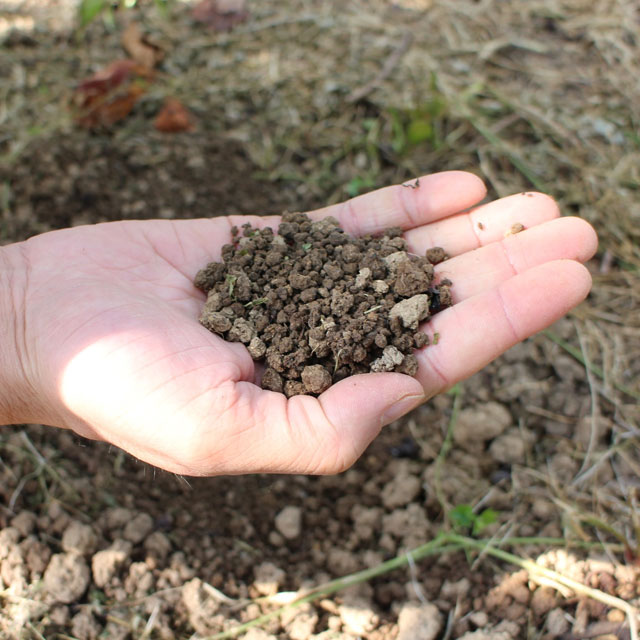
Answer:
[436,218,598,304]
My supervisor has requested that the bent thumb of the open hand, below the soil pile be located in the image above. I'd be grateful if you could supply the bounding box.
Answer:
[225,373,425,474]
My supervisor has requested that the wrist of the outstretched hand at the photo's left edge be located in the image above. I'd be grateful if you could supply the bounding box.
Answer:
[0,244,38,425]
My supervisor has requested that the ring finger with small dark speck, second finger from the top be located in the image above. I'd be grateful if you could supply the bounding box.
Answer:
[405,193,560,256]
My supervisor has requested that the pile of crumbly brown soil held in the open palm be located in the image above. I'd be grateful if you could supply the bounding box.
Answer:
[195,213,451,397]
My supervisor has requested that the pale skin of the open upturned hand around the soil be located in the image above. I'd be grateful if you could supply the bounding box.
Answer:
[0,172,597,475]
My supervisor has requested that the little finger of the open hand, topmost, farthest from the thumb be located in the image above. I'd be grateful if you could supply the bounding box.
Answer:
[309,171,486,235]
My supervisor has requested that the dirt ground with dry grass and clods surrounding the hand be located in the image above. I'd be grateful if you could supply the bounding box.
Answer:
[0,0,640,640]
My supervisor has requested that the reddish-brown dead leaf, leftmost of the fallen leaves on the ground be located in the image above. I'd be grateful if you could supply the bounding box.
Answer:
[72,59,153,129]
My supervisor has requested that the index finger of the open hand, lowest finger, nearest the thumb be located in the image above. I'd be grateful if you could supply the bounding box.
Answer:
[417,260,591,396]
